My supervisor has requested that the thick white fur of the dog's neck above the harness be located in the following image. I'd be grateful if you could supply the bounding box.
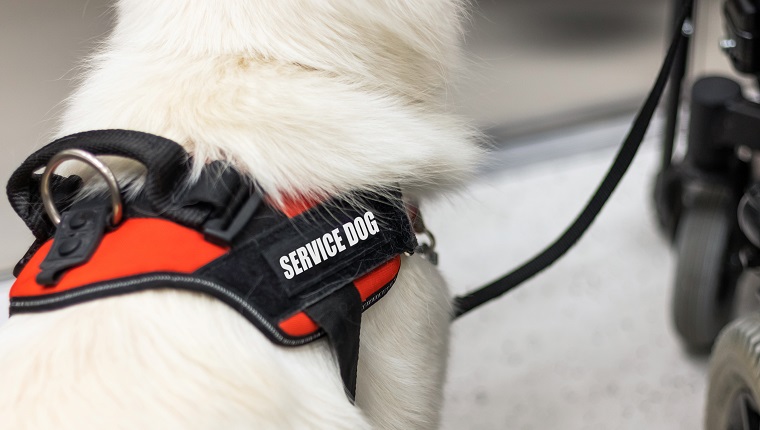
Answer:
[59,0,478,202]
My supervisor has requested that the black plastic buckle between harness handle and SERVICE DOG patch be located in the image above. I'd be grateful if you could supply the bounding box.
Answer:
[203,191,264,246]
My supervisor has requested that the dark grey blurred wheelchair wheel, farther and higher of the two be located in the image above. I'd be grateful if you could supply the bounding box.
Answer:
[672,187,736,352]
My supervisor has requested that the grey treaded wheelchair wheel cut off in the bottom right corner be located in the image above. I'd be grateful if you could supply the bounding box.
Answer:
[705,314,760,430]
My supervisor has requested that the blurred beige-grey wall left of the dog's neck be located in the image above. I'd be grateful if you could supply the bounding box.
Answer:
[0,0,110,273]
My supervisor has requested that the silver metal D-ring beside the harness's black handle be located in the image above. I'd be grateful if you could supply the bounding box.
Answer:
[40,149,124,227]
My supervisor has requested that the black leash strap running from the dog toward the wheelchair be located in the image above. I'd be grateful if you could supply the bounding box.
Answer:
[454,0,693,318]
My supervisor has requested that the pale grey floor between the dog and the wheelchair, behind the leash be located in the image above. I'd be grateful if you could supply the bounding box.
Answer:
[0,118,706,430]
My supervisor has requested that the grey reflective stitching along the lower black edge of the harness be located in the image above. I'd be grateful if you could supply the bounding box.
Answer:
[10,275,324,346]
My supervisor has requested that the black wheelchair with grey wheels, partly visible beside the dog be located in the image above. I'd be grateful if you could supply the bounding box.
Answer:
[654,0,760,430]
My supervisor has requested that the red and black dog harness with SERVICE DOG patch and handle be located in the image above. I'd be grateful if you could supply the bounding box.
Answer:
[7,130,416,400]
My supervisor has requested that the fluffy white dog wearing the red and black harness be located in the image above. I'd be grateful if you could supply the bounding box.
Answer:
[0,0,478,430]
